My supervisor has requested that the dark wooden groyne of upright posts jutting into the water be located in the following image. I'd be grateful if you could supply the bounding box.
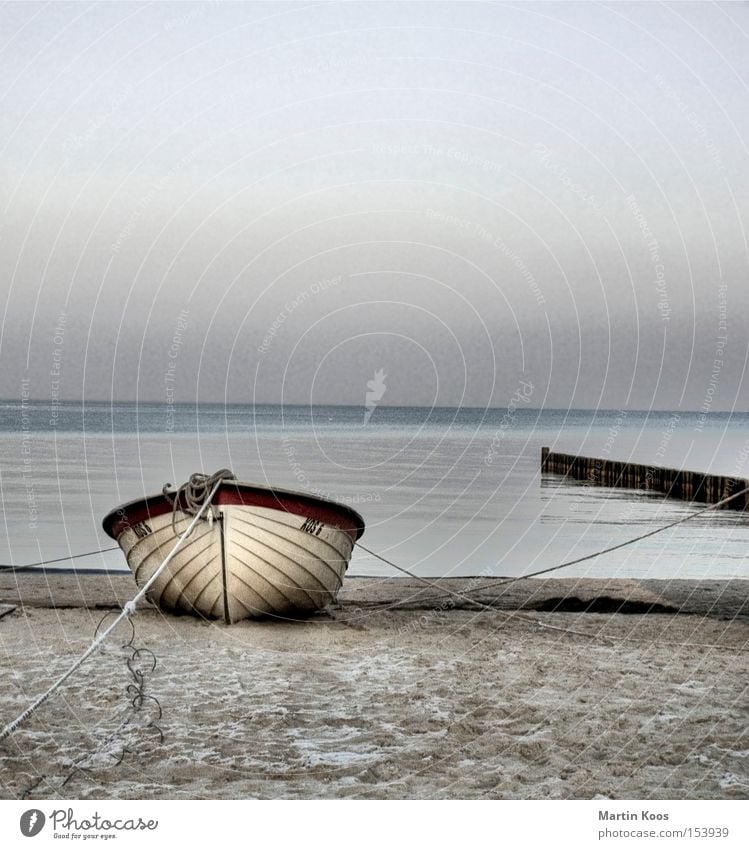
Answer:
[541,448,749,511]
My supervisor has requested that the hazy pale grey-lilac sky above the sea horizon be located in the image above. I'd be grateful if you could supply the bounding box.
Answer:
[0,2,749,412]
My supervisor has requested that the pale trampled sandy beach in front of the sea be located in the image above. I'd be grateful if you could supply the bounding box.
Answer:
[0,573,749,799]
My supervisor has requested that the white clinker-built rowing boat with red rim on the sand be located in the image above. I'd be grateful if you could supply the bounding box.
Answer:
[103,470,364,624]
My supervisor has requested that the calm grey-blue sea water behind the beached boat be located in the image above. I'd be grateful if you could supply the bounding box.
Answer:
[0,402,749,578]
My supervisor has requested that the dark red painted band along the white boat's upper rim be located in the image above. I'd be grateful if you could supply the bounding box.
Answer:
[102,480,365,542]
